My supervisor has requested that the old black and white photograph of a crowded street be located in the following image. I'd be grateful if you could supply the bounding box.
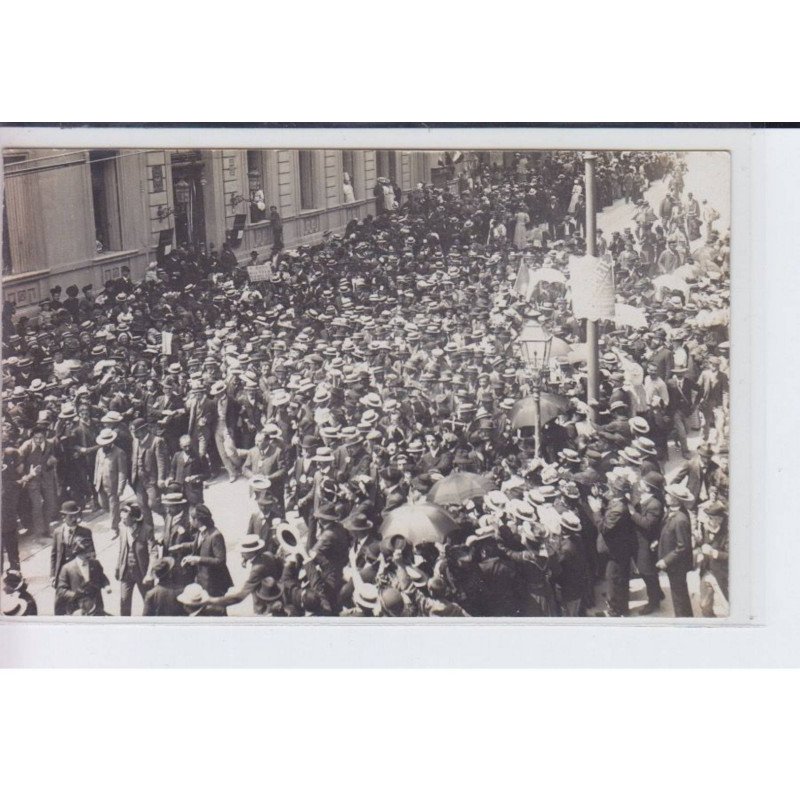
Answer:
[0,142,737,624]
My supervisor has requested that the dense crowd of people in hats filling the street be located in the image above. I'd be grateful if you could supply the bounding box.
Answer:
[2,151,730,617]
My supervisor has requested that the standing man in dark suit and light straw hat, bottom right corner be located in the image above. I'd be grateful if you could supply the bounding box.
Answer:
[656,483,695,617]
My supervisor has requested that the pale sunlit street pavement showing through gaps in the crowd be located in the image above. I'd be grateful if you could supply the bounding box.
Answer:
[7,153,730,617]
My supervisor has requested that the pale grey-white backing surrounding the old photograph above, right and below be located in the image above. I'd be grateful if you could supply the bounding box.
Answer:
[0,129,788,667]
